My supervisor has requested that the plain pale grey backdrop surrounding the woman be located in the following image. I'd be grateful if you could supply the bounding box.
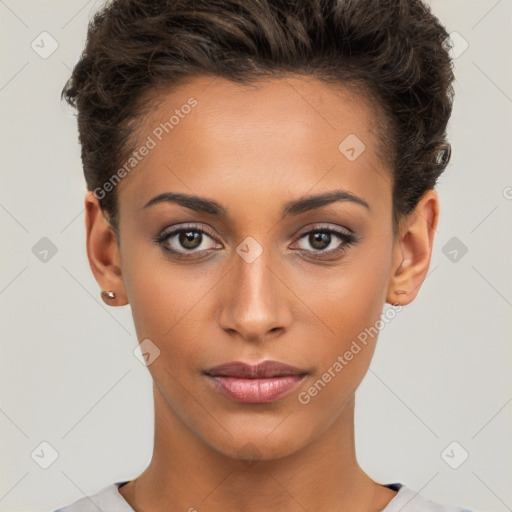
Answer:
[0,0,512,512]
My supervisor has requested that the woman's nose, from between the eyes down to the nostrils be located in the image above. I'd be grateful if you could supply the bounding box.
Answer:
[218,246,292,342]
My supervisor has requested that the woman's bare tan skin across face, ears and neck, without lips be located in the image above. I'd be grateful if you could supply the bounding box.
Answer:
[85,76,439,512]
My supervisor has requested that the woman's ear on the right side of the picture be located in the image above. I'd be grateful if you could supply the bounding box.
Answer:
[386,190,439,306]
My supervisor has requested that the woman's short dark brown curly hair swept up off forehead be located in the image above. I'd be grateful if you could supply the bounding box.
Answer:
[61,0,454,239]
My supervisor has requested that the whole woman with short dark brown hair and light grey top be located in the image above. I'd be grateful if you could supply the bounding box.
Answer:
[55,0,472,512]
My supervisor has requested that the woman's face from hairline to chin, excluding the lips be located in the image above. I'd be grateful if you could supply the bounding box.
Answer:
[105,77,400,459]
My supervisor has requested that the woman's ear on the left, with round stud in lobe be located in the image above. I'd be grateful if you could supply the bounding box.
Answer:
[85,191,128,306]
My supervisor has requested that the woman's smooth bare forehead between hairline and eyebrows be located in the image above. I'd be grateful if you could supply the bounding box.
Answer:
[118,76,389,213]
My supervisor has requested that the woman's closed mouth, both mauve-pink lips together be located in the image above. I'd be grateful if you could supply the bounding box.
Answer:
[203,361,308,404]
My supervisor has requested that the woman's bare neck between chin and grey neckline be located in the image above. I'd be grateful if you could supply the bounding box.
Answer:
[119,386,396,512]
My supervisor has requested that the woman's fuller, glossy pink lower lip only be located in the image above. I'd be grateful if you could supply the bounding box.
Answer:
[207,375,305,404]
